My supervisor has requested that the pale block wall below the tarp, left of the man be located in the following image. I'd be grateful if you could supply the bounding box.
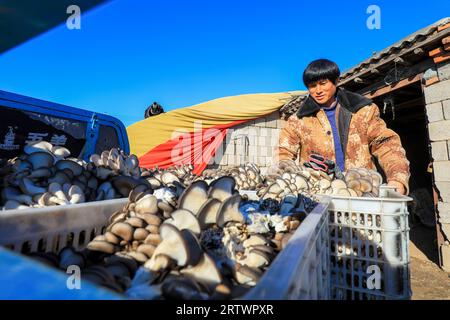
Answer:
[210,111,284,173]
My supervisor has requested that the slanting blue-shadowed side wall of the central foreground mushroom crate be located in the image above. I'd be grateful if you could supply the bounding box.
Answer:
[244,198,331,300]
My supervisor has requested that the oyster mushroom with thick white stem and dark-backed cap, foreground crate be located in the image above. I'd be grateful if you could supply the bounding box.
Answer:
[144,223,203,271]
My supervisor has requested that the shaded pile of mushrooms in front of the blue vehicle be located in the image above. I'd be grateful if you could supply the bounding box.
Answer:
[1,141,152,210]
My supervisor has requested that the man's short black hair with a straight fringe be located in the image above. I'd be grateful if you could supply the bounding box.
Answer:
[303,59,341,87]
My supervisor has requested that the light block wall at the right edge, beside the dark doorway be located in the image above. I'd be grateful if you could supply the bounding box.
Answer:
[424,62,450,271]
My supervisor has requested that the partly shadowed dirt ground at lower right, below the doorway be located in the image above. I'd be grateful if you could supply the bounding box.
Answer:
[409,225,450,300]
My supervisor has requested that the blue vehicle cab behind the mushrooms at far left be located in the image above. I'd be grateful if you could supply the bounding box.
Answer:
[0,90,130,160]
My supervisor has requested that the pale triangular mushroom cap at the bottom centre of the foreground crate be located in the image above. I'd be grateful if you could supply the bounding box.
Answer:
[180,253,222,290]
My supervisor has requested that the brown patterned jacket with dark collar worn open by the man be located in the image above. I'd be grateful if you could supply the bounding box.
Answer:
[274,88,410,192]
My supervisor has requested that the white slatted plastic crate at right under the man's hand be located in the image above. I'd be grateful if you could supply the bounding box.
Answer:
[329,186,412,300]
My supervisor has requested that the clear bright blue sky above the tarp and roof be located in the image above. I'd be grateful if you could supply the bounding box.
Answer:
[0,0,450,125]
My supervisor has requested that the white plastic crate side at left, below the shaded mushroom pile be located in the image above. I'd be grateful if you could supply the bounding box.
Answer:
[0,198,128,253]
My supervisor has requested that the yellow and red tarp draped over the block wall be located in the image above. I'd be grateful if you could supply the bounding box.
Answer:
[127,91,304,174]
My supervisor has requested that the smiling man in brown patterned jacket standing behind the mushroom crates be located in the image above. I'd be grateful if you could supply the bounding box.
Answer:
[275,59,410,194]
